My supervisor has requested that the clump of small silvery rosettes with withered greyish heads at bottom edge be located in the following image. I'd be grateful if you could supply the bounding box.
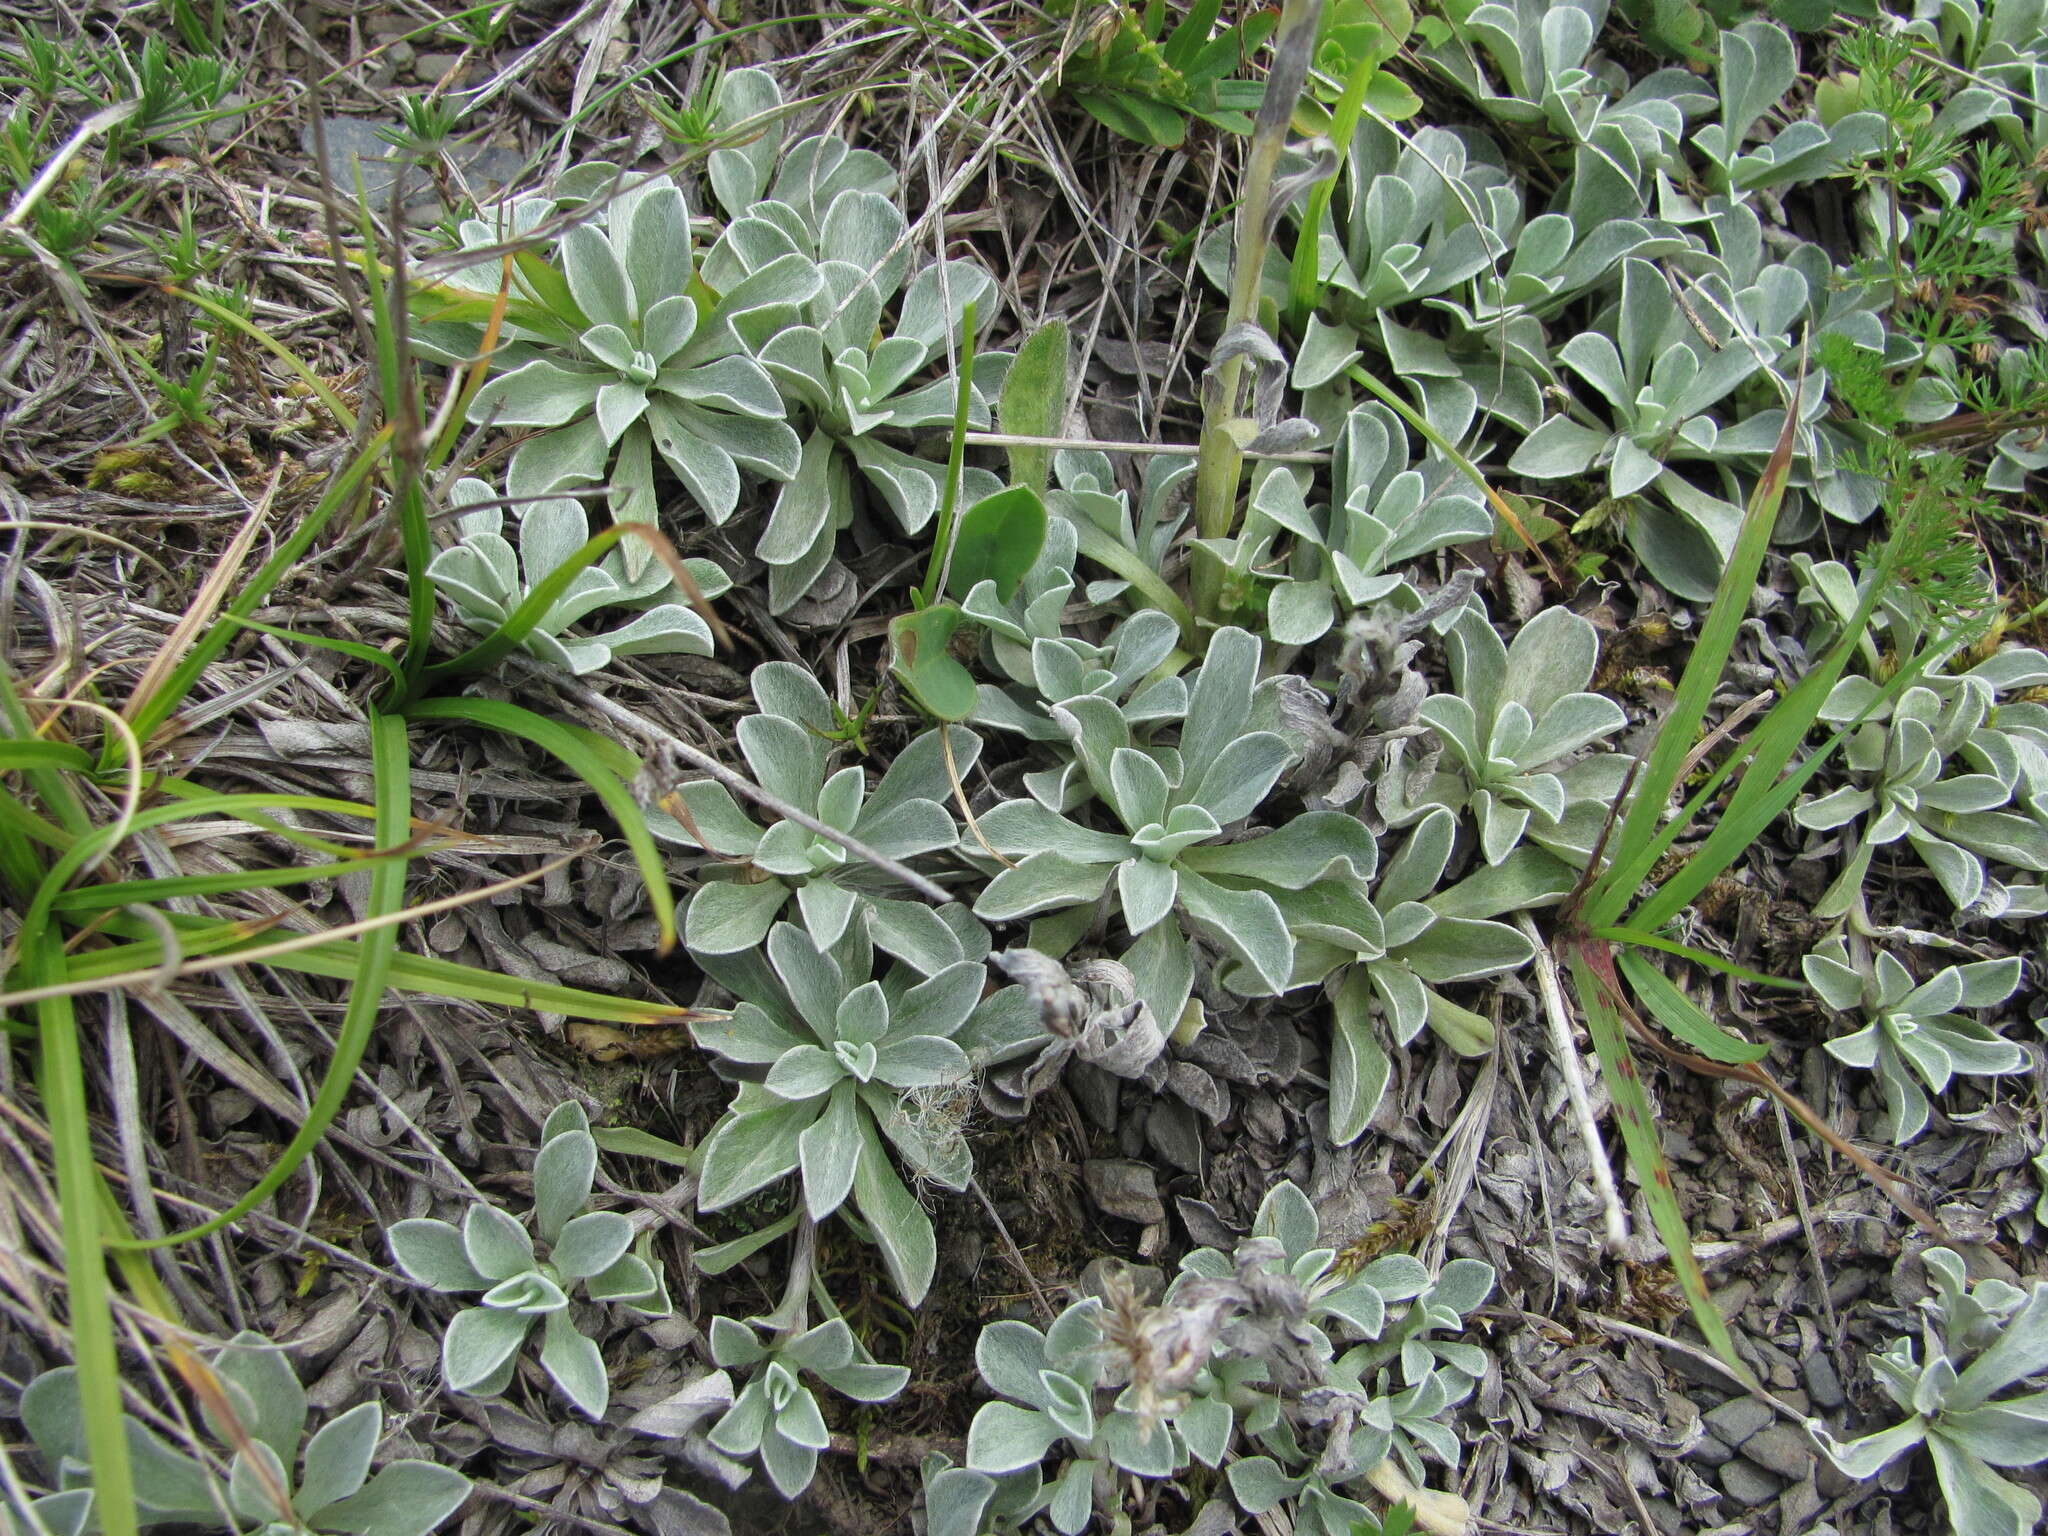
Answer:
[928,1184,1493,1536]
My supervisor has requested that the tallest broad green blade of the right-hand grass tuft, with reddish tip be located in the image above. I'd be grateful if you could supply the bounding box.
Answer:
[1581,399,1798,928]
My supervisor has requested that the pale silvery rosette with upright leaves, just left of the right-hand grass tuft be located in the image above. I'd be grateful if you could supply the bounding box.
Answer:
[1378,606,1628,864]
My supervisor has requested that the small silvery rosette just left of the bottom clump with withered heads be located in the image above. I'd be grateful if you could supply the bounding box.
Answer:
[707,1317,909,1499]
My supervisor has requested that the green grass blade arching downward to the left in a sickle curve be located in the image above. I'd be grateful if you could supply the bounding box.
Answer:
[107,713,412,1249]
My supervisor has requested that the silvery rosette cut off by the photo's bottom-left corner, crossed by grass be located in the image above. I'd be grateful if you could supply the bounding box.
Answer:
[17,1331,469,1536]
